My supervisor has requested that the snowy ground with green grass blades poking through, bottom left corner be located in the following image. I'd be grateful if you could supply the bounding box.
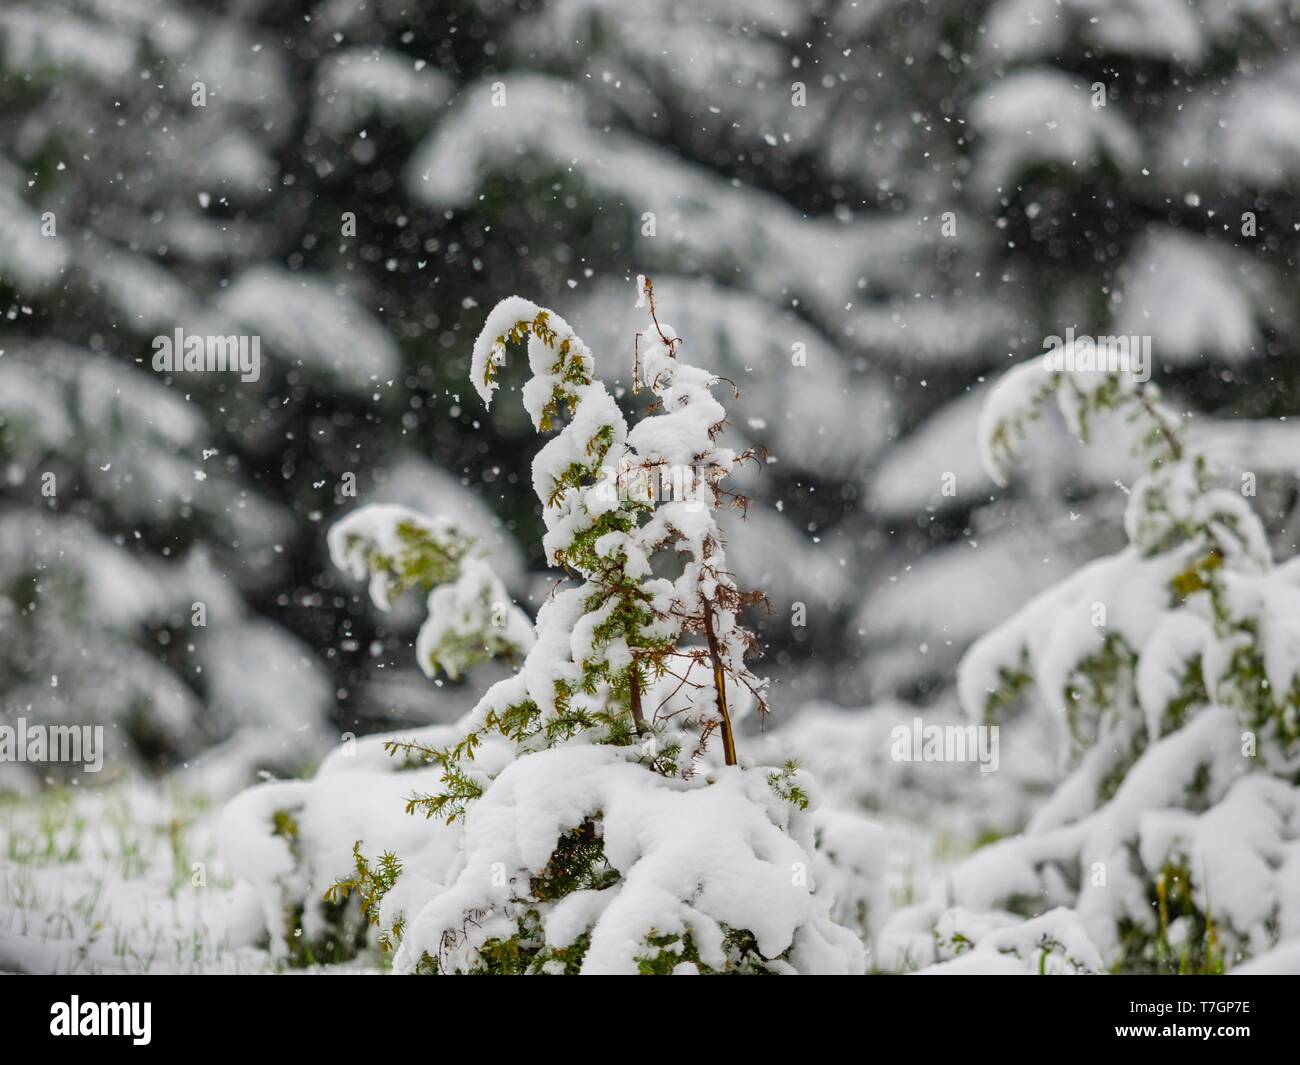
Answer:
[0,780,273,973]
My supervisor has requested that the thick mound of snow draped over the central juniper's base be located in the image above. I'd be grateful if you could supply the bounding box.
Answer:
[385,746,865,974]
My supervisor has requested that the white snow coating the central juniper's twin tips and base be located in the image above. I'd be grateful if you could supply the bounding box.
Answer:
[335,291,880,973]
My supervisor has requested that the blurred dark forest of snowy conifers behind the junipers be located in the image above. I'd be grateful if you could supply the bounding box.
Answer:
[0,0,1300,788]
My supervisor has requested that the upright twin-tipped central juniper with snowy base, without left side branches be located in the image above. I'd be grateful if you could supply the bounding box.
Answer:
[314,282,865,973]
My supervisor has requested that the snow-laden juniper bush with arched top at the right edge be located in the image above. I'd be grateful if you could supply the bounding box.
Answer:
[887,356,1300,973]
